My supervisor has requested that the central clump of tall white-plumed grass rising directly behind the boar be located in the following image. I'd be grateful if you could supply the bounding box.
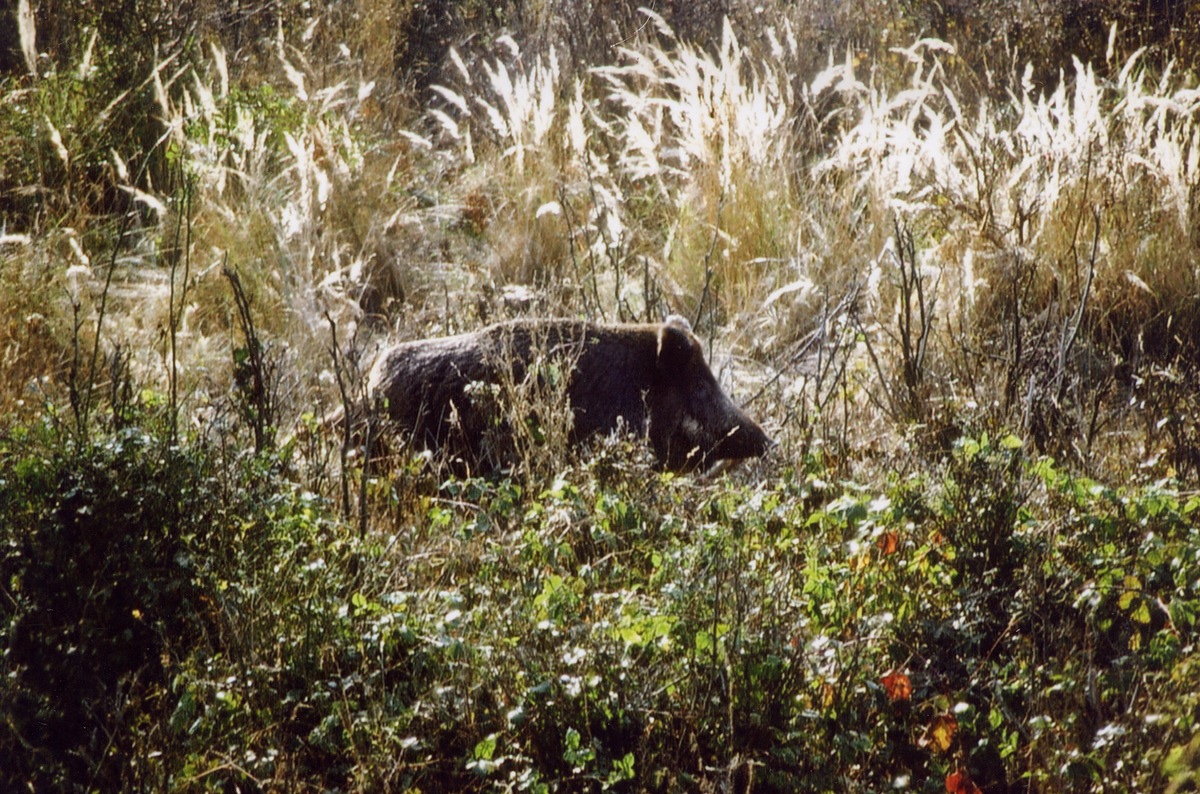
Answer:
[422,11,794,328]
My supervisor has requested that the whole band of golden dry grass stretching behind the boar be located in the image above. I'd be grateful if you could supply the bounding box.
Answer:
[5,3,1200,479]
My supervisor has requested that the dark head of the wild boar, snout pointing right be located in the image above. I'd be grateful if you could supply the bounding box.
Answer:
[648,315,775,471]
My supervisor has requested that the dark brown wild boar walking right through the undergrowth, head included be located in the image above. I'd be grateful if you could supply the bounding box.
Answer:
[368,318,773,471]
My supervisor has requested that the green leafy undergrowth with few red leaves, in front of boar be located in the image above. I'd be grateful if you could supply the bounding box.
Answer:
[0,412,1200,792]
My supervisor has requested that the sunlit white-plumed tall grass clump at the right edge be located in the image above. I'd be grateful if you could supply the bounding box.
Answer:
[815,42,1200,340]
